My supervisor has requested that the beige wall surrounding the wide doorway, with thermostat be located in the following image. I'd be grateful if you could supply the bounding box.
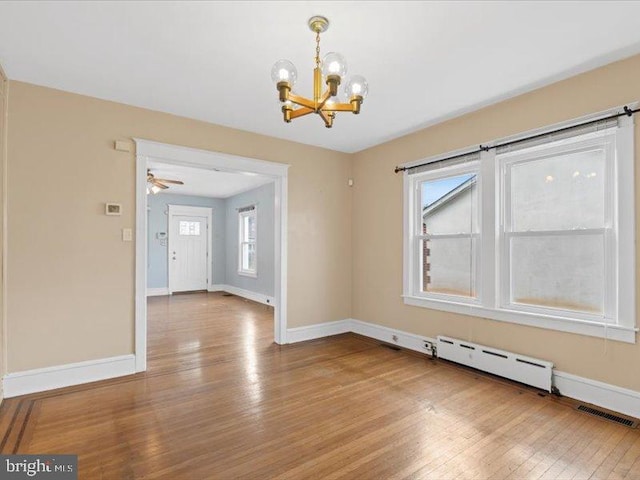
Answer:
[7,81,351,372]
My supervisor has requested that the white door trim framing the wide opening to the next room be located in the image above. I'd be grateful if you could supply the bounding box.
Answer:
[133,138,289,372]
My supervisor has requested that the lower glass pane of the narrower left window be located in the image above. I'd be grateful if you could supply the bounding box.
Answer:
[421,238,476,297]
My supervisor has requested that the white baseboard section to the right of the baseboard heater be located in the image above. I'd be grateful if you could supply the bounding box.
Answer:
[553,370,640,418]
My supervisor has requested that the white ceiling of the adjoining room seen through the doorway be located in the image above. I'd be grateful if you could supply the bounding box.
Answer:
[147,160,273,198]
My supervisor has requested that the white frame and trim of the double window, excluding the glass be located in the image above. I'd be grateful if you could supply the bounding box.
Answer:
[402,107,638,343]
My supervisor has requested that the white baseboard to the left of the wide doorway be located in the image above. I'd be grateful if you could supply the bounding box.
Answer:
[3,355,136,398]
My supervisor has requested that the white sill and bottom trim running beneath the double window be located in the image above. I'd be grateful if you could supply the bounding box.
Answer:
[402,295,638,343]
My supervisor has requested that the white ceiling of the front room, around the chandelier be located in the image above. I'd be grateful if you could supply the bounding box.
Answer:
[0,1,640,152]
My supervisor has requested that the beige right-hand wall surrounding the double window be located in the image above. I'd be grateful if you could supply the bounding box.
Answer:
[352,56,640,391]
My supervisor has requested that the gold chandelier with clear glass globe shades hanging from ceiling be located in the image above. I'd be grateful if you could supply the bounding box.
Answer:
[271,16,369,128]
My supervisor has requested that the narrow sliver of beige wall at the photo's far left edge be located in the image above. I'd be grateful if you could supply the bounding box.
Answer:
[0,66,9,402]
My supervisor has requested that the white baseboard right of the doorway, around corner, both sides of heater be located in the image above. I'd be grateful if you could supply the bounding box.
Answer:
[287,318,640,418]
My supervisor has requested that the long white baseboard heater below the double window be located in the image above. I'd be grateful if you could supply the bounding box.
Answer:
[437,335,553,392]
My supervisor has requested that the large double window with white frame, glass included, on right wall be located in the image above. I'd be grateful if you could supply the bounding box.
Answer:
[404,111,635,342]
